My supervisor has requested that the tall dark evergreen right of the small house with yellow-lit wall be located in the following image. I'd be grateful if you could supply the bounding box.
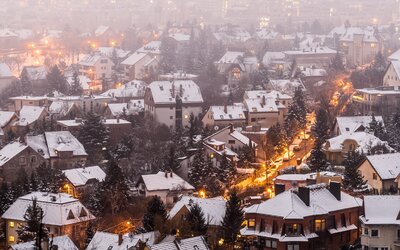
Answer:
[102,160,129,214]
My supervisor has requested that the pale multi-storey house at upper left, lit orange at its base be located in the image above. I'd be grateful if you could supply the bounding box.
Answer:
[78,54,114,84]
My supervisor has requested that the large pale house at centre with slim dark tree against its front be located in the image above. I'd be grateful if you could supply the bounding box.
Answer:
[144,80,204,129]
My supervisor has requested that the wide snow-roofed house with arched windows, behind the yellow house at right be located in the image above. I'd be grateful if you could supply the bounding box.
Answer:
[322,132,394,164]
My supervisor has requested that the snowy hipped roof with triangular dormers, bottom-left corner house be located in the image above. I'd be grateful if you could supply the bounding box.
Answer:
[2,192,95,226]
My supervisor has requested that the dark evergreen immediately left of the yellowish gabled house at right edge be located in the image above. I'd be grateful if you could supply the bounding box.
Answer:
[343,151,367,191]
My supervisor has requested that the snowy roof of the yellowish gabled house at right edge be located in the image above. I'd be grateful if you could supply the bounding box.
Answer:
[367,153,400,180]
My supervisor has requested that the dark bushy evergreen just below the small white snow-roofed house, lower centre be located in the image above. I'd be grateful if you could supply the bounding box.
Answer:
[142,196,167,232]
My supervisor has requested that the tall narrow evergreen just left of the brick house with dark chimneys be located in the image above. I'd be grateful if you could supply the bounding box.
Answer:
[222,190,243,245]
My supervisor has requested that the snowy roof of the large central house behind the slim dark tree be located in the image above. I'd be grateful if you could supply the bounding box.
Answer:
[148,80,203,104]
